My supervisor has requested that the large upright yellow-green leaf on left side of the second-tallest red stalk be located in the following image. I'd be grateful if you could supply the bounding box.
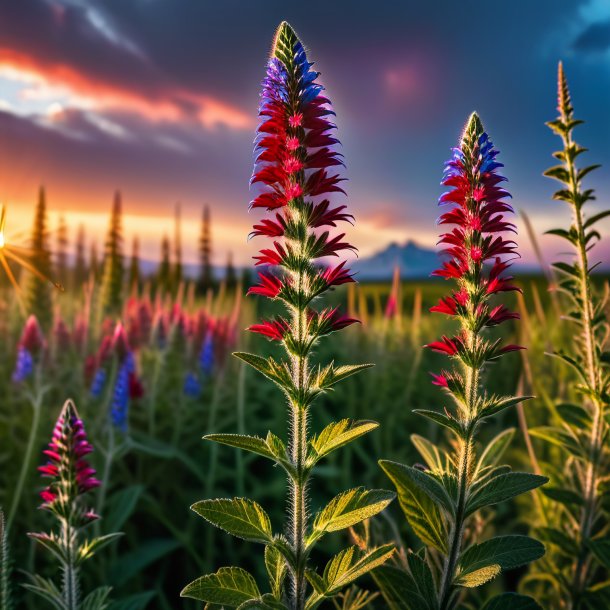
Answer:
[379,460,447,553]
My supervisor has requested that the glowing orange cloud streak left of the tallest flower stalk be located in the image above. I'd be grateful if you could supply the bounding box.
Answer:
[0,47,254,129]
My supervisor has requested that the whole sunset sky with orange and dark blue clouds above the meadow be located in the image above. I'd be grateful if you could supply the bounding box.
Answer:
[0,0,610,265]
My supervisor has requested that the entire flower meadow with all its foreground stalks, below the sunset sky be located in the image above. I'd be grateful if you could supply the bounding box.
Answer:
[0,16,610,610]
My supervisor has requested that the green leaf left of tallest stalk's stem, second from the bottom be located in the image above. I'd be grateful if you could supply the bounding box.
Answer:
[191,498,273,544]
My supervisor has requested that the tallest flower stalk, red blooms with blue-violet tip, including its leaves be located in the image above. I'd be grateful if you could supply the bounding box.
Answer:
[182,22,394,610]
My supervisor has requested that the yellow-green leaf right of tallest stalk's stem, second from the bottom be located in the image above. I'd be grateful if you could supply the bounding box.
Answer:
[307,487,396,545]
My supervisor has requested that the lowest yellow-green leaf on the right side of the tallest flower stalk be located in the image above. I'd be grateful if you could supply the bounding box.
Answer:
[305,544,396,610]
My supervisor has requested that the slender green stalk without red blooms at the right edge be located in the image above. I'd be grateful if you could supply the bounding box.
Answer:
[532,63,610,610]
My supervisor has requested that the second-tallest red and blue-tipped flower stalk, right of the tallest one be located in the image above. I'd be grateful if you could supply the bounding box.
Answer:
[378,113,547,610]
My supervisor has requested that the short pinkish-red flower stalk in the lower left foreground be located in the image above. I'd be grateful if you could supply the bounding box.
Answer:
[25,400,120,610]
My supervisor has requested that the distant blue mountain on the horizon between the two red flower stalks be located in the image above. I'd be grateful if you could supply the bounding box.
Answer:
[350,240,440,281]
